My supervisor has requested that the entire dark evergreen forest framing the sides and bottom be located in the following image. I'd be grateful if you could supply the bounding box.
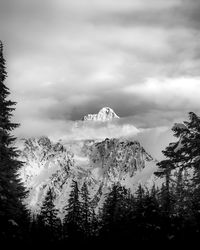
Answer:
[0,42,200,244]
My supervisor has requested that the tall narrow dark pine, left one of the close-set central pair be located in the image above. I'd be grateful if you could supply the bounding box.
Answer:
[64,180,82,240]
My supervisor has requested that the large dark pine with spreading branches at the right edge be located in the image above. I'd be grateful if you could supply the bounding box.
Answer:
[156,112,200,238]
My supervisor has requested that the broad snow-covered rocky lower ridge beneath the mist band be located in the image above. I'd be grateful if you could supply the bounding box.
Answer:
[19,137,157,216]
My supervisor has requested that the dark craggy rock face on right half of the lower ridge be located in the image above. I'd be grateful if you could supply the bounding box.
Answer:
[86,139,153,182]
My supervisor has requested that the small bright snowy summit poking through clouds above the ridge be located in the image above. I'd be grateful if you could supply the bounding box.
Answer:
[82,107,119,122]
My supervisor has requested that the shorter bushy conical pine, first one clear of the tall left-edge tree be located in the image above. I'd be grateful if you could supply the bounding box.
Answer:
[39,188,61,241]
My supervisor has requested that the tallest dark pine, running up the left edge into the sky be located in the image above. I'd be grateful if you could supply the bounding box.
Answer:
[0,41,26,239]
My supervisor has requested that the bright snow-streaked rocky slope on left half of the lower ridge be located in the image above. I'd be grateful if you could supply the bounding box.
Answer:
[19,137,74,213]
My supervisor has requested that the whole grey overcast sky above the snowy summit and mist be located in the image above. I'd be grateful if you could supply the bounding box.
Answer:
[0,0,200,154]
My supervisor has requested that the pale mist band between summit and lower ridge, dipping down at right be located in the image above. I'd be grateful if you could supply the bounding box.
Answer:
[13,111,176,160]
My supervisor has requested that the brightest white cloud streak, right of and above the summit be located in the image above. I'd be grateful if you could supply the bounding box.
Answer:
[124,78,200,110]
